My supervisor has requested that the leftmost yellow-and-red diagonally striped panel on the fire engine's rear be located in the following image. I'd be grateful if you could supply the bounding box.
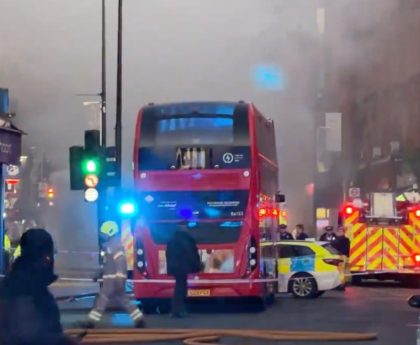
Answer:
[349,223,367,271]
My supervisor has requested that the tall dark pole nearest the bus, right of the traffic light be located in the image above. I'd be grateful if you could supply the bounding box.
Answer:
[115,0,123,186]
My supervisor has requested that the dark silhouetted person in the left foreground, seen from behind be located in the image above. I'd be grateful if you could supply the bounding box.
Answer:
[0,229,77,345]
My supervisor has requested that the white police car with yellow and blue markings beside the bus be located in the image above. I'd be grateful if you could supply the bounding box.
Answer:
[261,241,345,298]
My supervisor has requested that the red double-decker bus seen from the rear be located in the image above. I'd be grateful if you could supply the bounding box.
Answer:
[133,101,281,309]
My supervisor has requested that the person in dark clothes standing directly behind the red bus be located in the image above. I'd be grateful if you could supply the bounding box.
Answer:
[166,224,201,317]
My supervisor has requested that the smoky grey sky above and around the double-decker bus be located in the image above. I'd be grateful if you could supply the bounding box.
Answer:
[0,0,334,230]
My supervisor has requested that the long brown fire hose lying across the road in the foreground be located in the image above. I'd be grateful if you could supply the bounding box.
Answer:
[67,328,377,345]
